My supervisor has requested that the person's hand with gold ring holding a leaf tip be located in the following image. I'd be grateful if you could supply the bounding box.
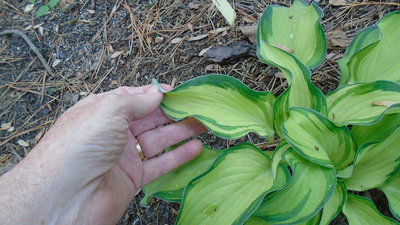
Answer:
[0,86,206,224]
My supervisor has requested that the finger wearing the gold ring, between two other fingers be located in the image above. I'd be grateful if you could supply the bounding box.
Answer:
[137,118,207,158]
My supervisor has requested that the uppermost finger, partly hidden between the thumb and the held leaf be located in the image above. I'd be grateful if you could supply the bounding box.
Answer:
[129,108,173,136]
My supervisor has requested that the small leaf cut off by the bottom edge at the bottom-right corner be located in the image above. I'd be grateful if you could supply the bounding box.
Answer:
[343,194,398,225]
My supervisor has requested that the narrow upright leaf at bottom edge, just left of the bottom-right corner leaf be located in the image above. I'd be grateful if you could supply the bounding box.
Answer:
[319,182,347,225]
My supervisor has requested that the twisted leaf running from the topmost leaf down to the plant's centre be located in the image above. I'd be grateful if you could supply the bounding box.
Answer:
[257,40,327,136]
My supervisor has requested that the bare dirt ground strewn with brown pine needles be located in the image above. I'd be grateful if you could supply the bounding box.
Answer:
[0,0,400,224]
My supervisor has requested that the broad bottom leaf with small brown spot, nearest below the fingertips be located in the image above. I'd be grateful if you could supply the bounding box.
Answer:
[176,143,273,225]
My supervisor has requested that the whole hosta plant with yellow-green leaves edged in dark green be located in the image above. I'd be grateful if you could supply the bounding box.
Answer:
[141,0,400,225]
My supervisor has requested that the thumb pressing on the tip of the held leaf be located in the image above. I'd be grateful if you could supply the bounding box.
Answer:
[106,86,163,121]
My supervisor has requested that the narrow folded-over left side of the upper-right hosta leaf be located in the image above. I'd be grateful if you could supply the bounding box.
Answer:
[338,25,382,86]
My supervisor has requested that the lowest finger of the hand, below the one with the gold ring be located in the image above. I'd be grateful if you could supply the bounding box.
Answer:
[143,140,202,185]
